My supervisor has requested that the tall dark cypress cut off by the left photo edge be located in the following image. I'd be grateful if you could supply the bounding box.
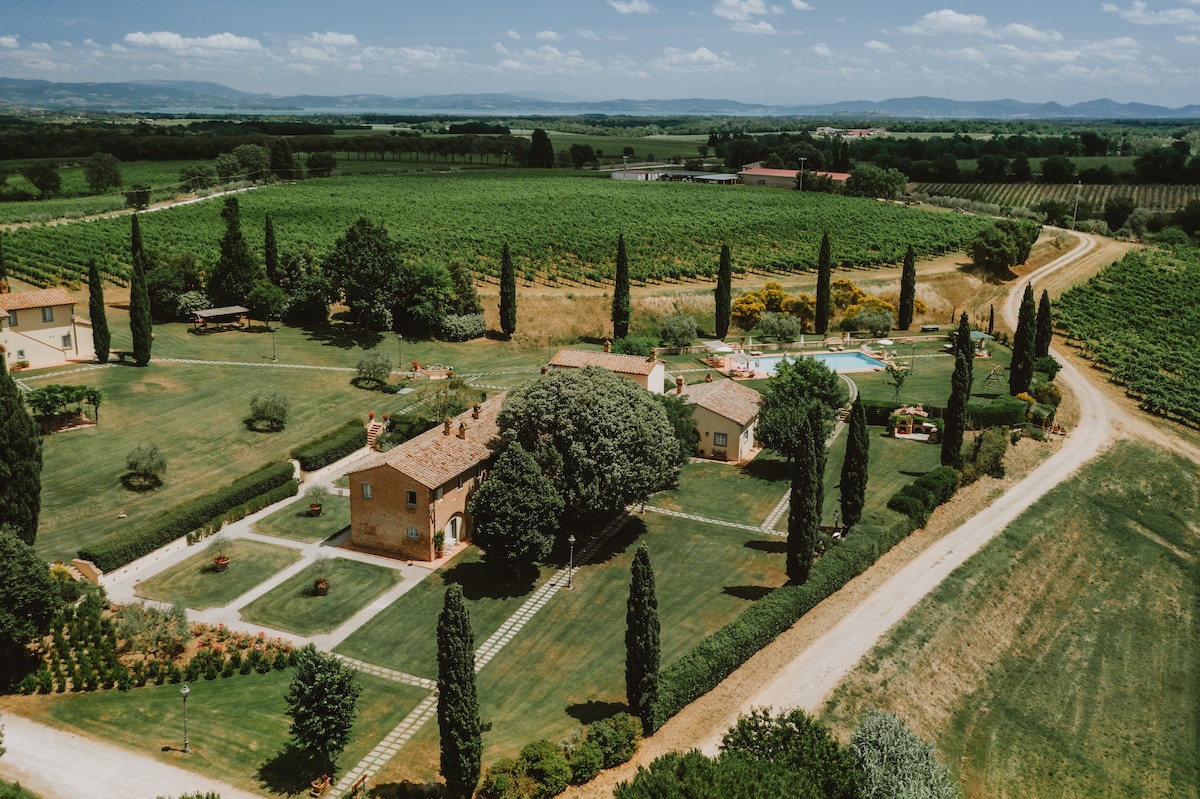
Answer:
[0,353,42,546]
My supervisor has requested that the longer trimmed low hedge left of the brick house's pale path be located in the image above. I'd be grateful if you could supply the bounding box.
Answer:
[78,462,295,571]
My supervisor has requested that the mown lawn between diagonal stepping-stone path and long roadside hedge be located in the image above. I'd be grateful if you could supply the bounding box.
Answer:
[377,513,785,783]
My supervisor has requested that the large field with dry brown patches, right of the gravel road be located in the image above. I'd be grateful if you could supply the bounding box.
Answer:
[824,443,1200,798]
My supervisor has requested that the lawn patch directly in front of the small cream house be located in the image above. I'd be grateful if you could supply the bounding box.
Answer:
[647,451,791,524]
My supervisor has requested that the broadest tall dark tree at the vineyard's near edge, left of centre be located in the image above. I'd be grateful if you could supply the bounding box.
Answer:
[324,217,401,330]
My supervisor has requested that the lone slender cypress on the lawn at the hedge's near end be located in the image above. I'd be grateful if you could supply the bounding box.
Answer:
[625,543,659,735]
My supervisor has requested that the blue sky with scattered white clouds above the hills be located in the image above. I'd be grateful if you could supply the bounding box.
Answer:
[0,0,1200,108]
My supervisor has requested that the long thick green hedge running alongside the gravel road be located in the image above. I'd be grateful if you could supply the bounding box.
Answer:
[650,511,914,729]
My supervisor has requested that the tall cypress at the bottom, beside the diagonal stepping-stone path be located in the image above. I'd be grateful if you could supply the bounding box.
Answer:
[438,583,484,799]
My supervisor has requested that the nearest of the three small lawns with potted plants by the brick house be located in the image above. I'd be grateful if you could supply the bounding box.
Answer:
[241,558,401,636]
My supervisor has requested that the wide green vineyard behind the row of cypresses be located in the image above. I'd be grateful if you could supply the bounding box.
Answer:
[5,173,990,286]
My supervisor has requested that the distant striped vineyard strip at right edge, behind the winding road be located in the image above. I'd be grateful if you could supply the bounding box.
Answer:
[910,184,1200,211]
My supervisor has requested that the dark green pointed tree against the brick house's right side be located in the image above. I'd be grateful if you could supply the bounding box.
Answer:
[469,443,563,578]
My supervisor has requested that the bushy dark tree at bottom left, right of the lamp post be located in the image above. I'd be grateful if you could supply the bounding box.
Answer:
[287,644,362,774]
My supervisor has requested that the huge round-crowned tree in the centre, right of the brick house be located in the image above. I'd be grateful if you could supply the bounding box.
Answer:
[498,366,678,519]
